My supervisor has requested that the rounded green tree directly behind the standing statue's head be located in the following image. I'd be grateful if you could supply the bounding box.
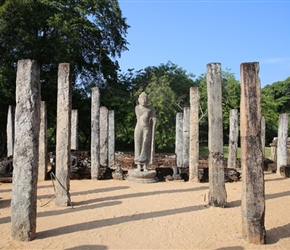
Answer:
[102,62,195,150]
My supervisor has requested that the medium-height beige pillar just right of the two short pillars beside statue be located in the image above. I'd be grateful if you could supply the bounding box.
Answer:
[189,87,199,182]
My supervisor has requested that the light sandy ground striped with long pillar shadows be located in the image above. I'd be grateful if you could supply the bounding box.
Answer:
[0,173,290,250]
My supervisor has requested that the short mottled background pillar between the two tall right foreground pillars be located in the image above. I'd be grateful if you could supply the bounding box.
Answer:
[228,109,239,168]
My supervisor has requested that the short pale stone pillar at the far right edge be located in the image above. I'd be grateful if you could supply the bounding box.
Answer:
[277,114,289,175]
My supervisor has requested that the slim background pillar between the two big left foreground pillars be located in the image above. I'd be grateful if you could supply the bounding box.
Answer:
[38,102,47,181]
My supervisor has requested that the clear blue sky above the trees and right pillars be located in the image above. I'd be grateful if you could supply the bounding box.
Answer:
[118,0,290,87]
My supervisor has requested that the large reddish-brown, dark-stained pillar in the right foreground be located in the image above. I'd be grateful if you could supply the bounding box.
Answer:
[240,62,266,244]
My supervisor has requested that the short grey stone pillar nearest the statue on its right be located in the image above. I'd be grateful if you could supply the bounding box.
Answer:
[175,112,183,167]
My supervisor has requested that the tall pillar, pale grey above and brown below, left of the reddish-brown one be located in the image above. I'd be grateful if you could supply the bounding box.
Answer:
[206,63,227,207]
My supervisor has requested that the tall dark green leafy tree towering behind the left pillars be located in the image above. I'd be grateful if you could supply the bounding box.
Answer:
[0,0,129,154]
